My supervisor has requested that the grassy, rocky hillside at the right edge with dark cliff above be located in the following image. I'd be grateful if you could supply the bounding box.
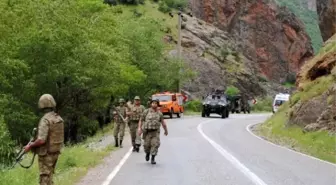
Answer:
[258,0,336,162]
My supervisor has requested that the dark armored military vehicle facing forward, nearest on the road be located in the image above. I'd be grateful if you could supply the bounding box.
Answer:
[202,91,230,119]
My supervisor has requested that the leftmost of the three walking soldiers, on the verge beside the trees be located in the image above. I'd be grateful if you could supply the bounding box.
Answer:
[113,98,127,148]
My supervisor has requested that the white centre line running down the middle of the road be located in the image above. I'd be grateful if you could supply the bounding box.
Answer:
[197,120,267,185]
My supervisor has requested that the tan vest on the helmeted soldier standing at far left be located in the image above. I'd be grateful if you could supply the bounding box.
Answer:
[37,112,64,155]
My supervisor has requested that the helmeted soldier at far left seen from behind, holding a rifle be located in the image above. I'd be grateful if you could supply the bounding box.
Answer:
[25,94,64,185]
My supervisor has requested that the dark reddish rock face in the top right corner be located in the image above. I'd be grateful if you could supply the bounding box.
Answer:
[316,0,336,41]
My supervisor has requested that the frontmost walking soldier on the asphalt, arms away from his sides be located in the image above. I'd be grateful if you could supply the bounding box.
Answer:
[138,100,168,164]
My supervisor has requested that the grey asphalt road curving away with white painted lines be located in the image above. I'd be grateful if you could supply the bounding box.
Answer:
[75,114,336,185]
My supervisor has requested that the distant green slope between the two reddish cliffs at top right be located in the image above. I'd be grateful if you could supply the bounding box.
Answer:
[275,0,323,53]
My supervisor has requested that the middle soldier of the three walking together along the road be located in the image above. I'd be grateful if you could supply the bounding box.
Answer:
[128,96,146,152]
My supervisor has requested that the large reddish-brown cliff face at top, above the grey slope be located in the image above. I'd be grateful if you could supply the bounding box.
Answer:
[189,0,313,83]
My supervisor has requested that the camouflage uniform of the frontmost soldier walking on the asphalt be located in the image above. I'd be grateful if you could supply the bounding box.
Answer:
[141,108,163,156]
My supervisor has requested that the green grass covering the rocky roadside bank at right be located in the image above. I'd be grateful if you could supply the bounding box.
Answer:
[257,33,336,163]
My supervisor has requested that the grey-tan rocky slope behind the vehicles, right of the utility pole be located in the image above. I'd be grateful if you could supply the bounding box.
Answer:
[166,15,292,98]
